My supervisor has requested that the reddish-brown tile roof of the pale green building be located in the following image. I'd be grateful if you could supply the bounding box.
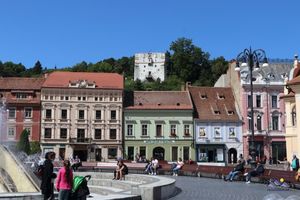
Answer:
[125,91,193,110]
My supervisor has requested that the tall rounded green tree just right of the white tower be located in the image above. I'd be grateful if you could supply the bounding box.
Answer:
[170,38,210,83]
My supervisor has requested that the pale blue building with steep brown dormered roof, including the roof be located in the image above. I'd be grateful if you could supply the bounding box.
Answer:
[188,86,243,166]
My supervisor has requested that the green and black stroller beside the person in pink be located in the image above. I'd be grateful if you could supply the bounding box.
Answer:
[70,175,91,200]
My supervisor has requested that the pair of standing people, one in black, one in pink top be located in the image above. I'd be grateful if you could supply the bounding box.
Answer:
[41,152,73,200]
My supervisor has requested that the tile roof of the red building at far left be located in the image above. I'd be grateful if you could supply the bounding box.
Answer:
[0,77,45,91]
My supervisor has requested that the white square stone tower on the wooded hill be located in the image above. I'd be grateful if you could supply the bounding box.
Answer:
[134,53,166,81]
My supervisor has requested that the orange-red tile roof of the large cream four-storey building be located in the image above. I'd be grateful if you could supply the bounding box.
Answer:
[43,71,124,89]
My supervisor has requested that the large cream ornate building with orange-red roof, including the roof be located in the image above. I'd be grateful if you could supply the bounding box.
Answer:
[41,72,123,161]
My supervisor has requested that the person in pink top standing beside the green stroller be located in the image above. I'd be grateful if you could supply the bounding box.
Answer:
[56,160,73,200]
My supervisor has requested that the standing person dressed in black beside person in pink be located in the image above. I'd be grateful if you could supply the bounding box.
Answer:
[41,151,56,200]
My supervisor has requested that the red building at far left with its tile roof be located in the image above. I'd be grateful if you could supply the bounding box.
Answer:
[0,77,45,142]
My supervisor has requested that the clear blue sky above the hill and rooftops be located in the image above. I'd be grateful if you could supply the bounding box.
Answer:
[0,0,300,69]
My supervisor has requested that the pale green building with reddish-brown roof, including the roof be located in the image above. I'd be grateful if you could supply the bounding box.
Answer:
[124,91,195,161]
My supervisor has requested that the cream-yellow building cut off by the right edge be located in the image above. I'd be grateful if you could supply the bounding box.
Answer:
[282,56,300,162]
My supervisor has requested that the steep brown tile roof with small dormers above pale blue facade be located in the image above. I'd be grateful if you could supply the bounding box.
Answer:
[188,86,241,122]
